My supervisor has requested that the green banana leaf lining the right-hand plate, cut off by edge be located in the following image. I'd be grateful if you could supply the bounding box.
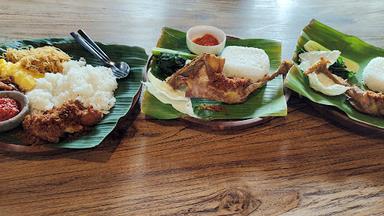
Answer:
[285,20,384,128]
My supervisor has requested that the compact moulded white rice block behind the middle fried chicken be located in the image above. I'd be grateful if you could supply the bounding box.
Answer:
[221,46,269,82]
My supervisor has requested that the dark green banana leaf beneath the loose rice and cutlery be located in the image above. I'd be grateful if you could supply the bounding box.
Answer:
[0,38,148,149]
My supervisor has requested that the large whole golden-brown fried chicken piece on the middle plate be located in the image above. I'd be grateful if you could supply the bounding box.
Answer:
[167,54,292,104]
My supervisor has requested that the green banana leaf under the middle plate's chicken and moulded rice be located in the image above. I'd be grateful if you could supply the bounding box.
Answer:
[142,27,287,120]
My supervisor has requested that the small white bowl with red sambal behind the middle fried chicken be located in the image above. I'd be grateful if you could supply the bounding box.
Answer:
[186,25,227,55]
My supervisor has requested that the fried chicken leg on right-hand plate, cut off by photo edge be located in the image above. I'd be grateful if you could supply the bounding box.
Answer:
[304,58,384,116]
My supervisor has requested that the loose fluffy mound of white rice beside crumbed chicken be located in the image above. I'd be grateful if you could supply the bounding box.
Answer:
[26,61,117,114]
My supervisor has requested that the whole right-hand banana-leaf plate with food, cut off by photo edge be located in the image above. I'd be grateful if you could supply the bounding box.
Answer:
[285,20,384,132]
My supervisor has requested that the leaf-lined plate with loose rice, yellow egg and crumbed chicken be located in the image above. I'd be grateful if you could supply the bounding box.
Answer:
[0,38,148,153]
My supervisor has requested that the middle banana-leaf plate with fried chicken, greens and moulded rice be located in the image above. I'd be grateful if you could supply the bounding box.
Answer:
[142,27,290,130]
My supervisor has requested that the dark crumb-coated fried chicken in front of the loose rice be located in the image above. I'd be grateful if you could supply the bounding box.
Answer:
[23,100,103,143]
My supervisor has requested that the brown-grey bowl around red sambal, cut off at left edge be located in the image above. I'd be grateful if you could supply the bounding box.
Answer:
[0,91,29,132]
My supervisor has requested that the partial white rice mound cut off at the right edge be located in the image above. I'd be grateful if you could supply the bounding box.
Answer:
[363,57,384,92]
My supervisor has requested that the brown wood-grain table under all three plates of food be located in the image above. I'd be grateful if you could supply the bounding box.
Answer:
[0,0,384,216]
